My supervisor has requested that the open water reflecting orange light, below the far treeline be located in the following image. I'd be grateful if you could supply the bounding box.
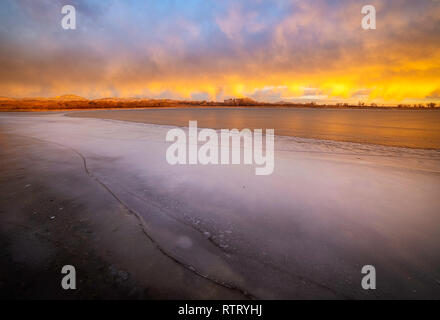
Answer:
[70,108,440,149]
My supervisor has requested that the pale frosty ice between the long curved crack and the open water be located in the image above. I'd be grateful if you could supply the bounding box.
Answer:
[0,114,440,299]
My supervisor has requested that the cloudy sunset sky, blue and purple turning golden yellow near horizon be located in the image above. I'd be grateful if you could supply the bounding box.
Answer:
[0,0,440,104]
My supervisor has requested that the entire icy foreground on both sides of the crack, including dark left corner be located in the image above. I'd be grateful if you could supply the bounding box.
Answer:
[0,115,440,299]
